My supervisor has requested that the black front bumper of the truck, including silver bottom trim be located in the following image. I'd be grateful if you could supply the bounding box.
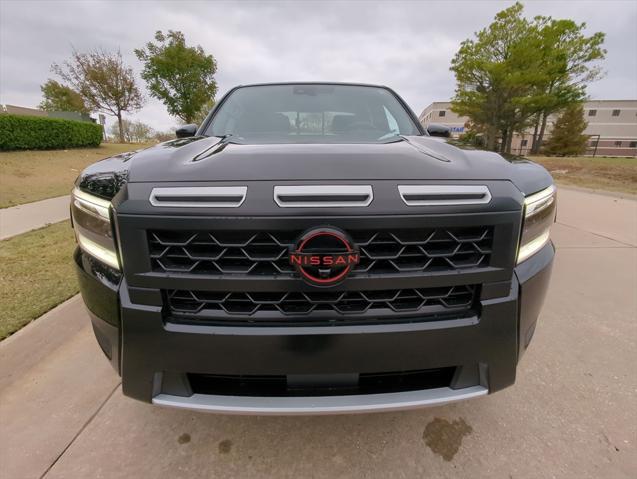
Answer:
[75,240,554,414]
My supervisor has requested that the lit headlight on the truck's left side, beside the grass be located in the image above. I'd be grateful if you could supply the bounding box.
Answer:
[71,188,120,270]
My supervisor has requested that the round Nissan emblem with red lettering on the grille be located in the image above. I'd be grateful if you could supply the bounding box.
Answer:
[290,227,360,286]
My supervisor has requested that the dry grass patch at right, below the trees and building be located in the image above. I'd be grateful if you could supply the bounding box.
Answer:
[529,156,637,194]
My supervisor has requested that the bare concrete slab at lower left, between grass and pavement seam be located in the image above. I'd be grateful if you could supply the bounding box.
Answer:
[0,296,119,479]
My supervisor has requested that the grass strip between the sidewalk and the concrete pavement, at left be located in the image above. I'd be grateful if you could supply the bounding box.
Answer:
[0,221,79,339]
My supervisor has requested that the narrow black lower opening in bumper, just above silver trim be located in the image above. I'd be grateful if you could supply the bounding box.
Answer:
[188,367,456,397]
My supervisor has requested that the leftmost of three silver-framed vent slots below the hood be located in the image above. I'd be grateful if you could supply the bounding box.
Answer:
[150,186,248,208]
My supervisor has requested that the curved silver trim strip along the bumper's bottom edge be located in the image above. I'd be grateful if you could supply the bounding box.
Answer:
[153,386,489,415]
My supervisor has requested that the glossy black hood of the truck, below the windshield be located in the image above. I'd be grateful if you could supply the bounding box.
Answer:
[82,136,552,194]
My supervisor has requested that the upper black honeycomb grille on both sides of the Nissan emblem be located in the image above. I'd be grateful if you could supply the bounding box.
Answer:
[148,226,493,276]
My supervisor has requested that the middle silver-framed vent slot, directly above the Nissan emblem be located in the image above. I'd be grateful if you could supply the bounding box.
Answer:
[274,185,374,208]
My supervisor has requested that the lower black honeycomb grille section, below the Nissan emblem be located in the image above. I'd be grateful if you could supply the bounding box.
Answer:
[165,285,478,324]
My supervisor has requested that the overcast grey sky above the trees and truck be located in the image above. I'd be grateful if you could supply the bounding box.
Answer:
[0,0,637,130]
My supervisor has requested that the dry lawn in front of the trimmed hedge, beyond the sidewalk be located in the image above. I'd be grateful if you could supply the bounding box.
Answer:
[0,143,148,208]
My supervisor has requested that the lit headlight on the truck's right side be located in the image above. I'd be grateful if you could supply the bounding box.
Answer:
[517,185,557,264]
